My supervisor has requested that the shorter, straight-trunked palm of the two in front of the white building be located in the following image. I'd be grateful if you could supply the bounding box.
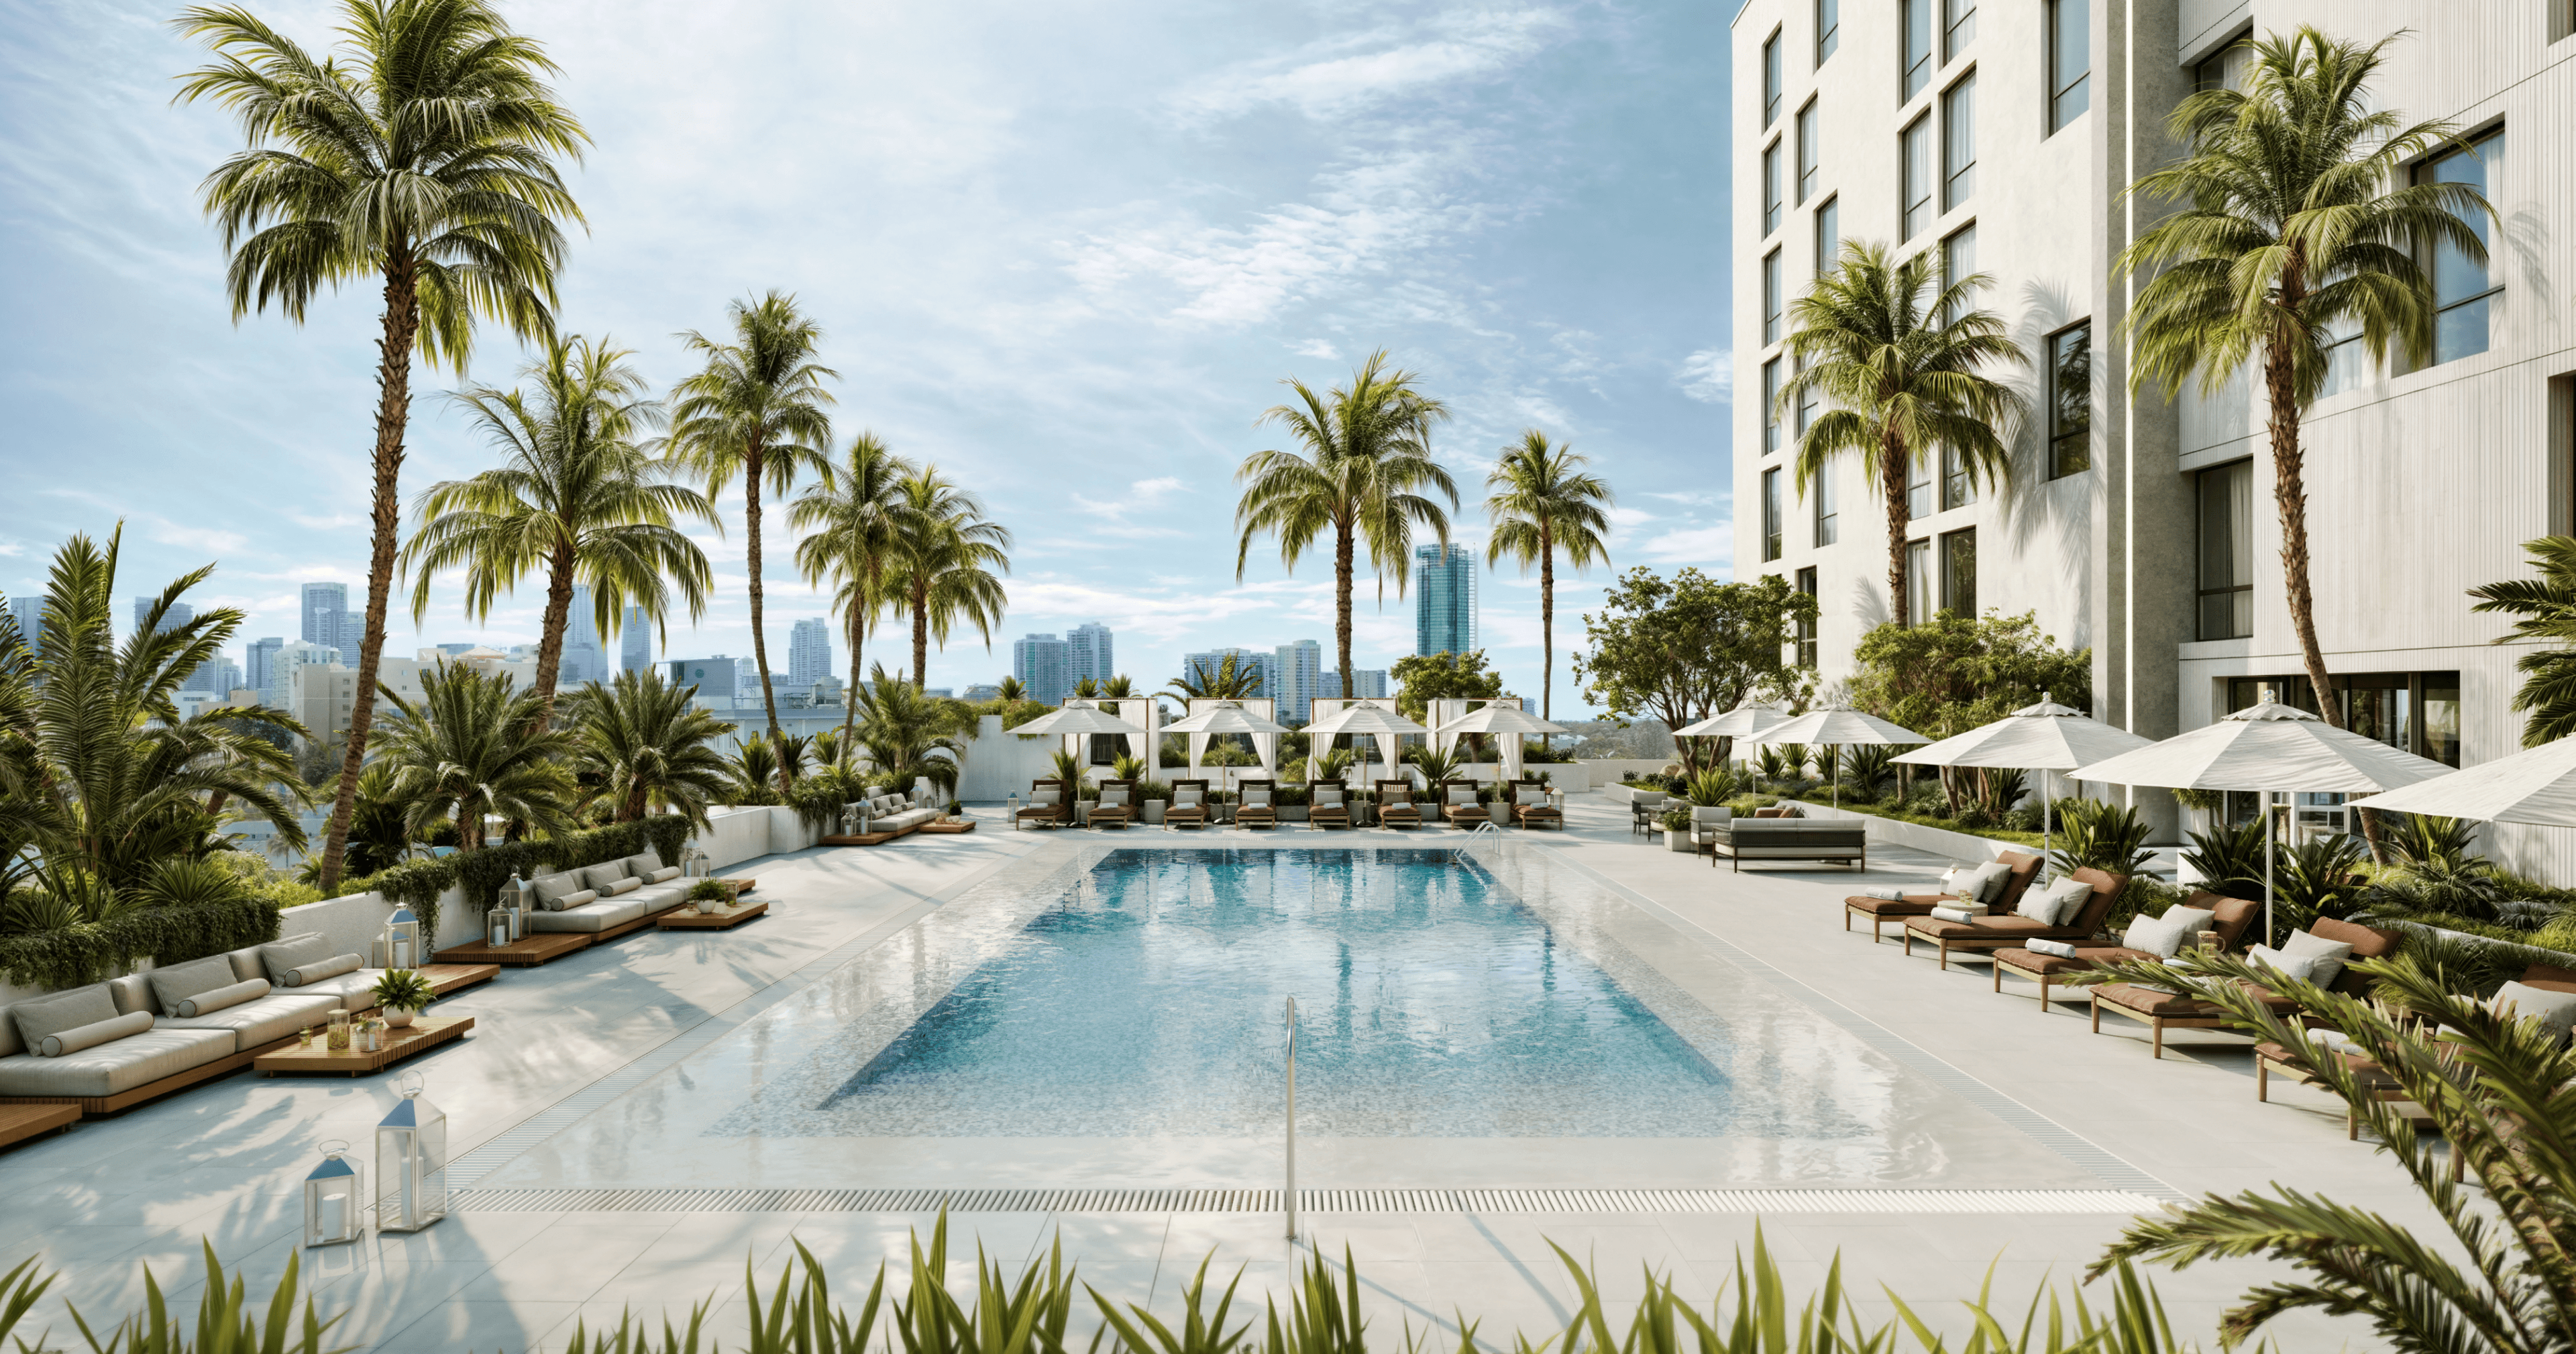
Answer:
[1775,240,2030,625]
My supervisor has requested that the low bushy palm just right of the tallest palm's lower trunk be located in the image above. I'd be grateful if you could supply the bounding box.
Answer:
[374,664,574,852]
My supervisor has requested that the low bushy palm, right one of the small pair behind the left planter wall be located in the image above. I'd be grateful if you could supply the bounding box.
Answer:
[567,669,734,829]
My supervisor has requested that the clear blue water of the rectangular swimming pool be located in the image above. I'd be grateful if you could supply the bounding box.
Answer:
[809,849,1860,1138]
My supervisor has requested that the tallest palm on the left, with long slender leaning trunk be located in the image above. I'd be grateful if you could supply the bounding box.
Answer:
[175,0,590,893]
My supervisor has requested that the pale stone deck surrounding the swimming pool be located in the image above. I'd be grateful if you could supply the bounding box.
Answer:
[0,795,2432,1351]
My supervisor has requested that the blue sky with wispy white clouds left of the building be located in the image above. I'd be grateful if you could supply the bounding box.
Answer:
[0,0,1731,713]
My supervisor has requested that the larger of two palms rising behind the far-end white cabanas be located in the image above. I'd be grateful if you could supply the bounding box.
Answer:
[1234,350,1458,690]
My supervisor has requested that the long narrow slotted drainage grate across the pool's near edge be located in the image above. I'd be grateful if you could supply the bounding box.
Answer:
[451,1189,2161,1212]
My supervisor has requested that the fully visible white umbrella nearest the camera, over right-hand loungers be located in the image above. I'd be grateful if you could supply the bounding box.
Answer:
[2069,700,2450,939]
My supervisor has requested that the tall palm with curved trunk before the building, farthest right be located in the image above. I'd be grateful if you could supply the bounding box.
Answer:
[2117,25,2493,751]
